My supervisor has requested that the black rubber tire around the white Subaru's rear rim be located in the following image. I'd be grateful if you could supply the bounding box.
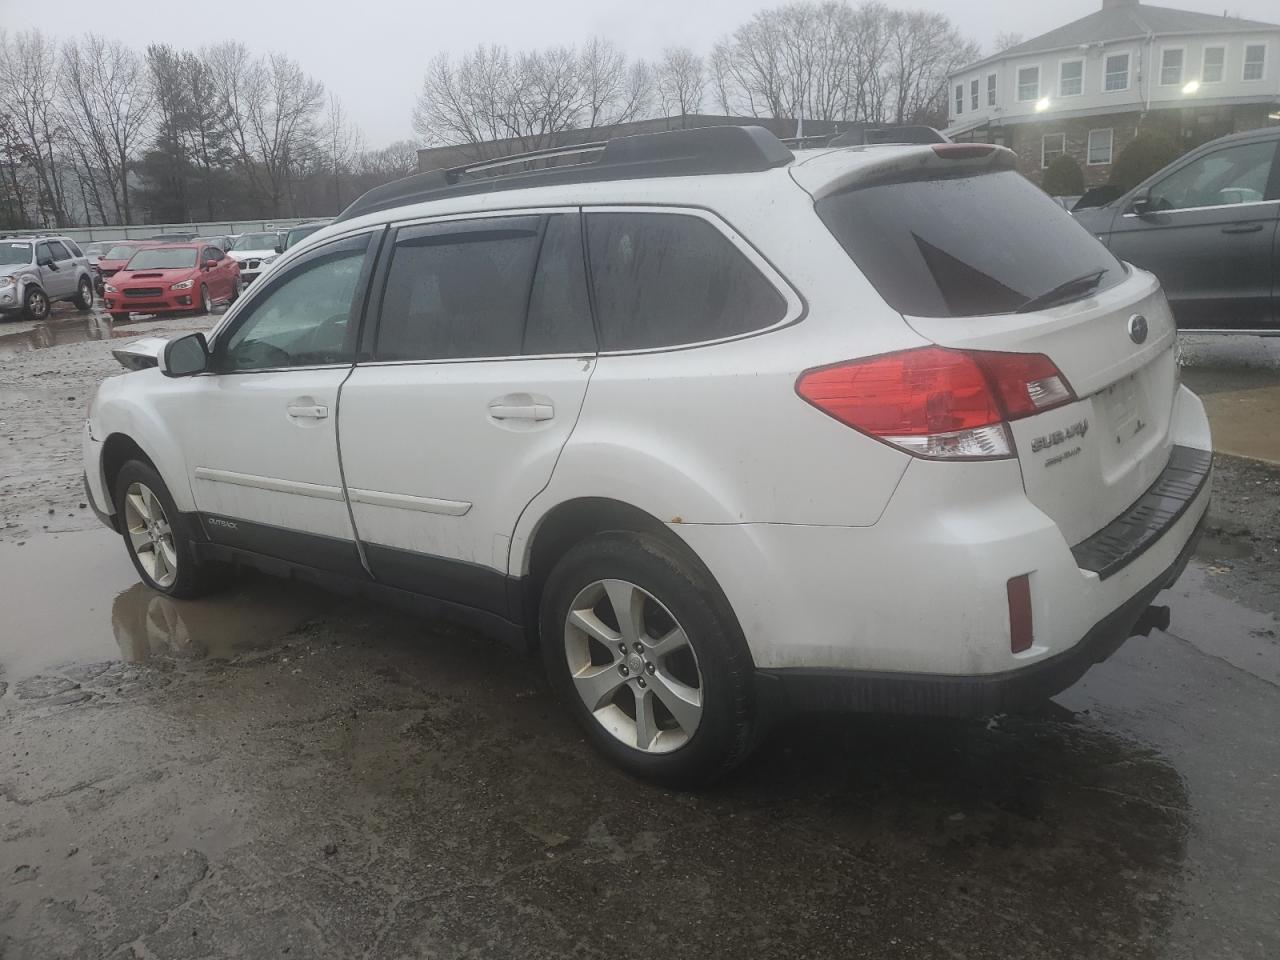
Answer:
[539,531,756,786]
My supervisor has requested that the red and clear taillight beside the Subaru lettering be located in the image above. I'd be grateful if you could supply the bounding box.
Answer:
[796,347,1075,460]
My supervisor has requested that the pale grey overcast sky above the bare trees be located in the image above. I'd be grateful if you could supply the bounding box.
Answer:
[0,0,1280,146]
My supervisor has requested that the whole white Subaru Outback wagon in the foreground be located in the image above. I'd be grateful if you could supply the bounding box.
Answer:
[84,127,1211,782]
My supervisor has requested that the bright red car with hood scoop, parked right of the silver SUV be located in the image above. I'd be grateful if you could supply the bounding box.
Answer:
[104,243,241,320]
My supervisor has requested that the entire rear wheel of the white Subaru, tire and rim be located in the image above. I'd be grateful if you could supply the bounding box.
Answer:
[540,531,755,785]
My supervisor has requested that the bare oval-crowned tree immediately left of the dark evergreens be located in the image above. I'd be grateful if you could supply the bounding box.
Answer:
[60,33,152,223]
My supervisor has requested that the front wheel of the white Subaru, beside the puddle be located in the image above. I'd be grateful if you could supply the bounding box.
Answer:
[115,460,223,596]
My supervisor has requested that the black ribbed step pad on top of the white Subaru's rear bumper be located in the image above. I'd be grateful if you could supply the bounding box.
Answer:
[1071,447,1213,580]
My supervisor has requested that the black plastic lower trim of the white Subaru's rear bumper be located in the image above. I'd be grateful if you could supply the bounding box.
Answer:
[756,516,1204,717]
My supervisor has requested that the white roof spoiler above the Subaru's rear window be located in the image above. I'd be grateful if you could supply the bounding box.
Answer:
[791,143,1018,200]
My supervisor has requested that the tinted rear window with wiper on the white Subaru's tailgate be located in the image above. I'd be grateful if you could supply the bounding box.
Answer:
[817,170,1124,316]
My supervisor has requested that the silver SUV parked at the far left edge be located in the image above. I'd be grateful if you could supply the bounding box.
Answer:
[0,236,93,320]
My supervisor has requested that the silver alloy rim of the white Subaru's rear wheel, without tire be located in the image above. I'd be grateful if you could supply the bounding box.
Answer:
[564,580,703,754]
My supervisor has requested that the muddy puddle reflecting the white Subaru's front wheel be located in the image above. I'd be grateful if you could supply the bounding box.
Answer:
[0,530,334,682]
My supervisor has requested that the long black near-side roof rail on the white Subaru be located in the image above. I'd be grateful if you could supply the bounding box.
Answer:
[334,125,795,223]
